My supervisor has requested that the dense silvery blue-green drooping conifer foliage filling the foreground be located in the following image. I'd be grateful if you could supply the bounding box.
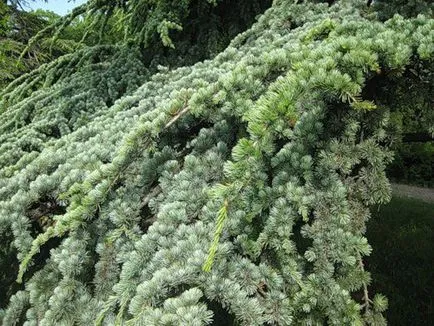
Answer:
[0,0,434,325]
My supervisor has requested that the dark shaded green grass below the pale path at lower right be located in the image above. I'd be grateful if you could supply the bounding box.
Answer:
[366,197,434,326]
